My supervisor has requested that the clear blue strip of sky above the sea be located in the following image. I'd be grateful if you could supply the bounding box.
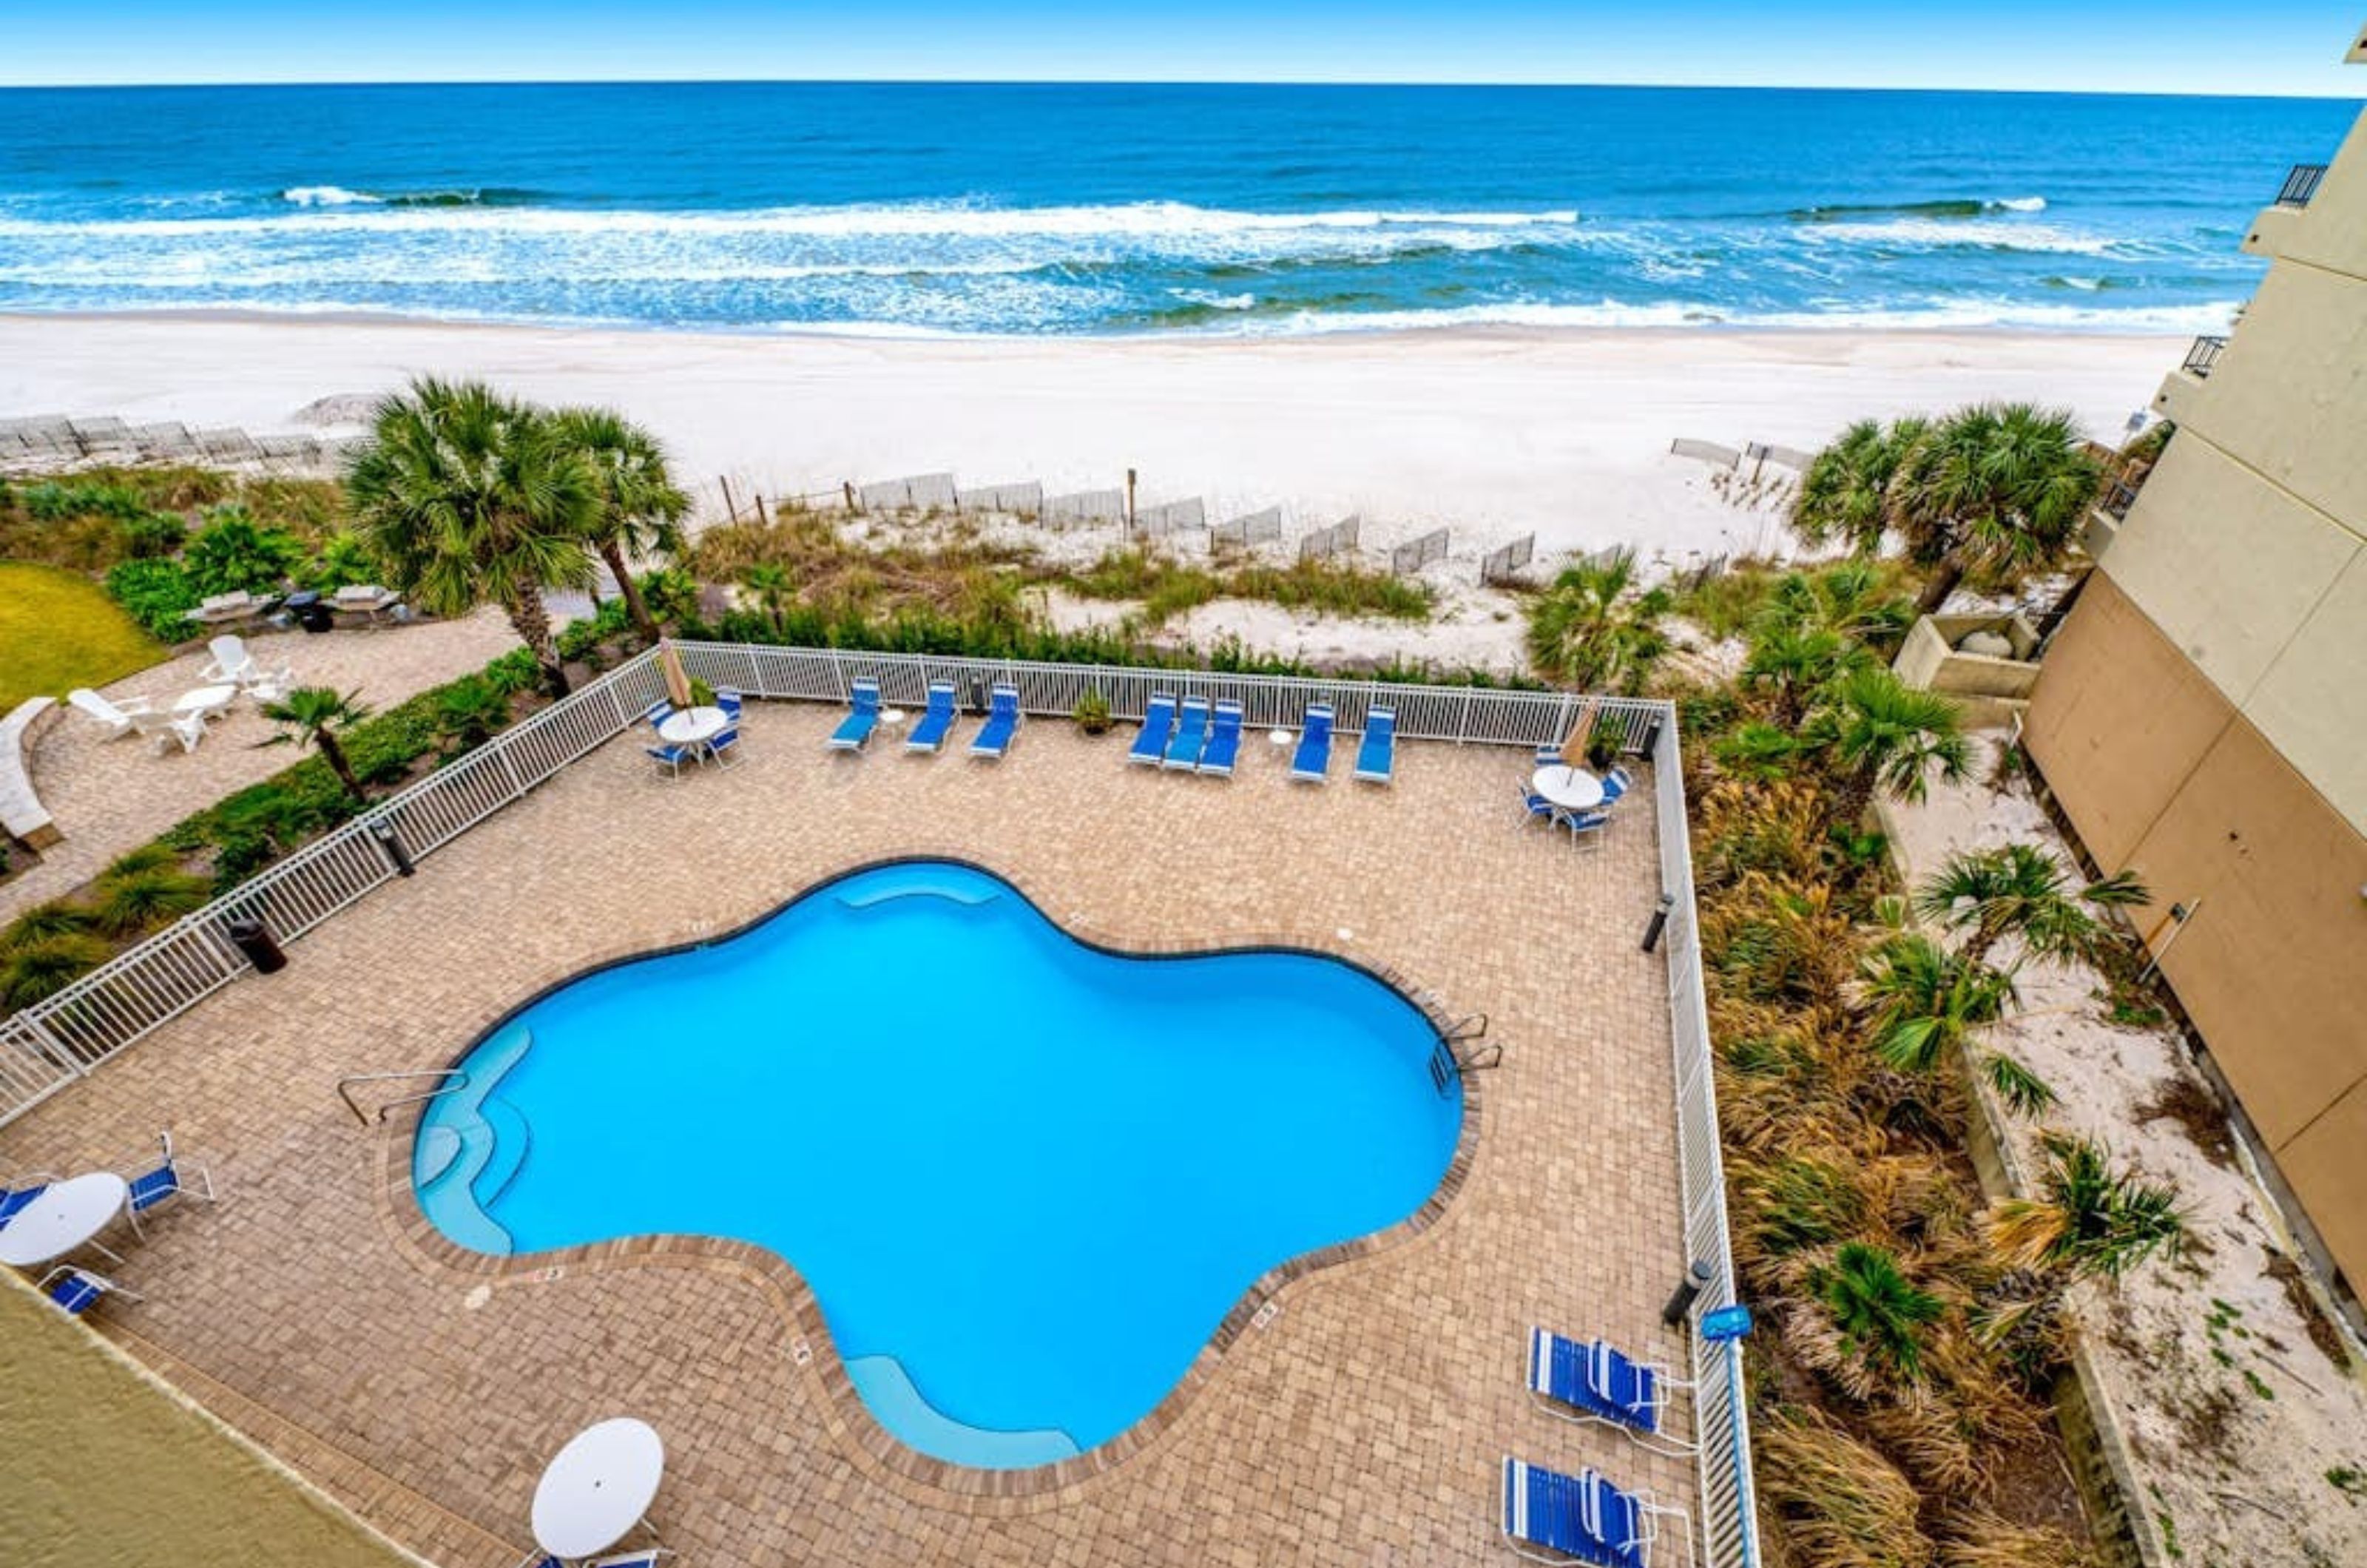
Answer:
[0,0,2367,97]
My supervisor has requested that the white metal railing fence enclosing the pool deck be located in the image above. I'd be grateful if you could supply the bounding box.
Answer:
[0,642,1759,1568]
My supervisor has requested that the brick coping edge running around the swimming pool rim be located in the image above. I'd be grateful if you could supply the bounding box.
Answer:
[374,848,1484,1513]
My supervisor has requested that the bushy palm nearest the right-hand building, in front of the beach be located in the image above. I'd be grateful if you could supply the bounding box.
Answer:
[1884,402,2104,616]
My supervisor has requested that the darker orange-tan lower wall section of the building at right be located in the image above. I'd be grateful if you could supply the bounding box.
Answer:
[2024,578,2367,1286]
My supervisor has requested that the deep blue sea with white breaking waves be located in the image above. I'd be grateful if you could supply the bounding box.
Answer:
[0,83,2357,334]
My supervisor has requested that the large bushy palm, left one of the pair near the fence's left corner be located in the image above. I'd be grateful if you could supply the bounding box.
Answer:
[345,376,601,697]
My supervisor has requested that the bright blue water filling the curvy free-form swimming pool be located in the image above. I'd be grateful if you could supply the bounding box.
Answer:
[414,862,1463,1468]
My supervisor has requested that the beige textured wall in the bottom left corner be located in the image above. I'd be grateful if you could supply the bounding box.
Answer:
[0,1269,416,1568]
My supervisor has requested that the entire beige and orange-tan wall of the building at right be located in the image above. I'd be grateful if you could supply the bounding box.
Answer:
[2026,55,2367,1291]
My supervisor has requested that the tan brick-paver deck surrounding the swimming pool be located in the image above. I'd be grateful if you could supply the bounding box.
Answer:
[0,703,1695,1568]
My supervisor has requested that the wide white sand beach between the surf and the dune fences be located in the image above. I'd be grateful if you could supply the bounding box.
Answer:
[0,315,2182,564]
